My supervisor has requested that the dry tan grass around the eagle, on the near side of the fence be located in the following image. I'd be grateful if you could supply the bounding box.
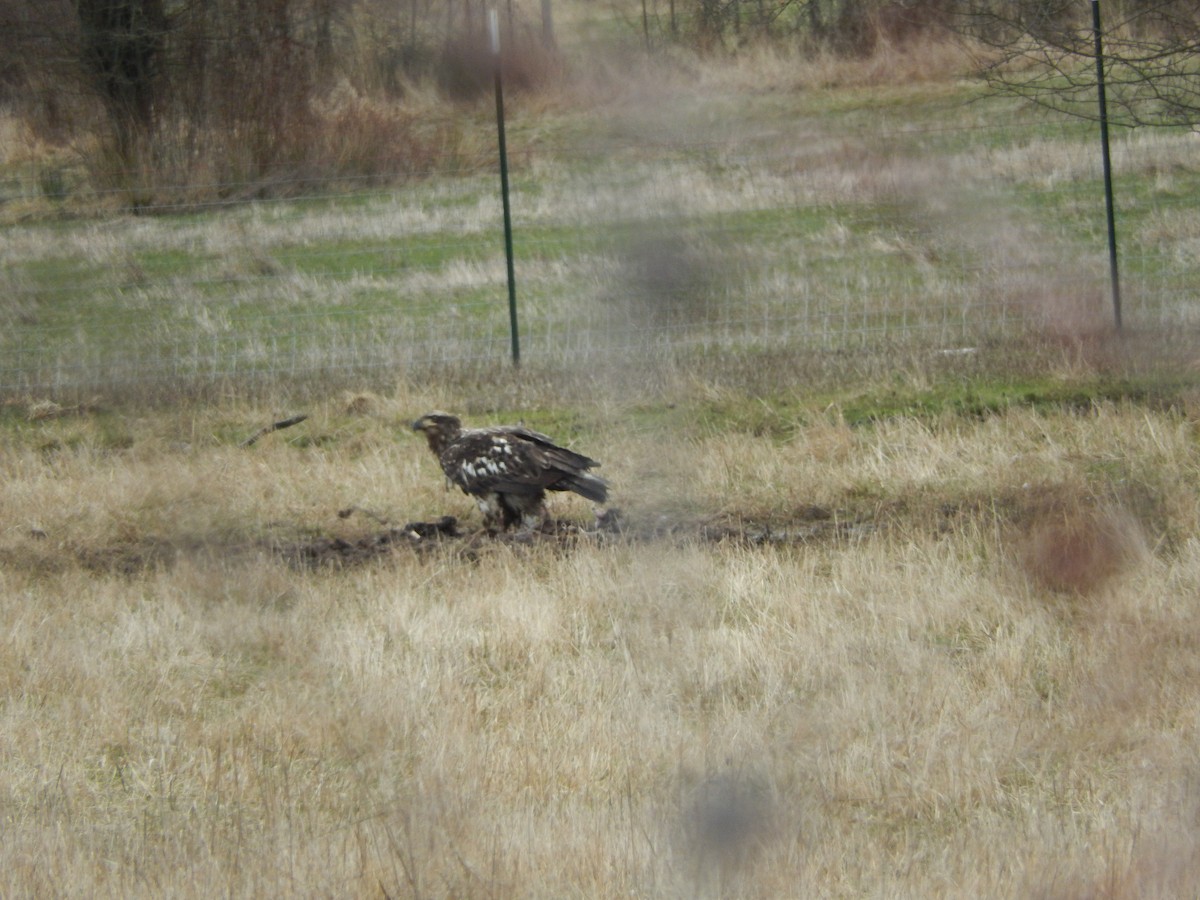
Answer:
[0,384,1200,898]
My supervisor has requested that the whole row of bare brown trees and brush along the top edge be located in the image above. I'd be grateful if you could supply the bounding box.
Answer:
[0,0,1200,204]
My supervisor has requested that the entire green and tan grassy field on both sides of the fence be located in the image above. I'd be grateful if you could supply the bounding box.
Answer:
[0,24,1200,900]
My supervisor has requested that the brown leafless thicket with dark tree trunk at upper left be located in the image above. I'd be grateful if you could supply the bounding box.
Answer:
[0,0,544,204]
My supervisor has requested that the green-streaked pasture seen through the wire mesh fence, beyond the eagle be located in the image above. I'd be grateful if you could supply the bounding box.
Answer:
[0,96,1200,396]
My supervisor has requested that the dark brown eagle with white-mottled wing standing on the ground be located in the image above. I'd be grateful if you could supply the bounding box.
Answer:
[413,413,608,532]
